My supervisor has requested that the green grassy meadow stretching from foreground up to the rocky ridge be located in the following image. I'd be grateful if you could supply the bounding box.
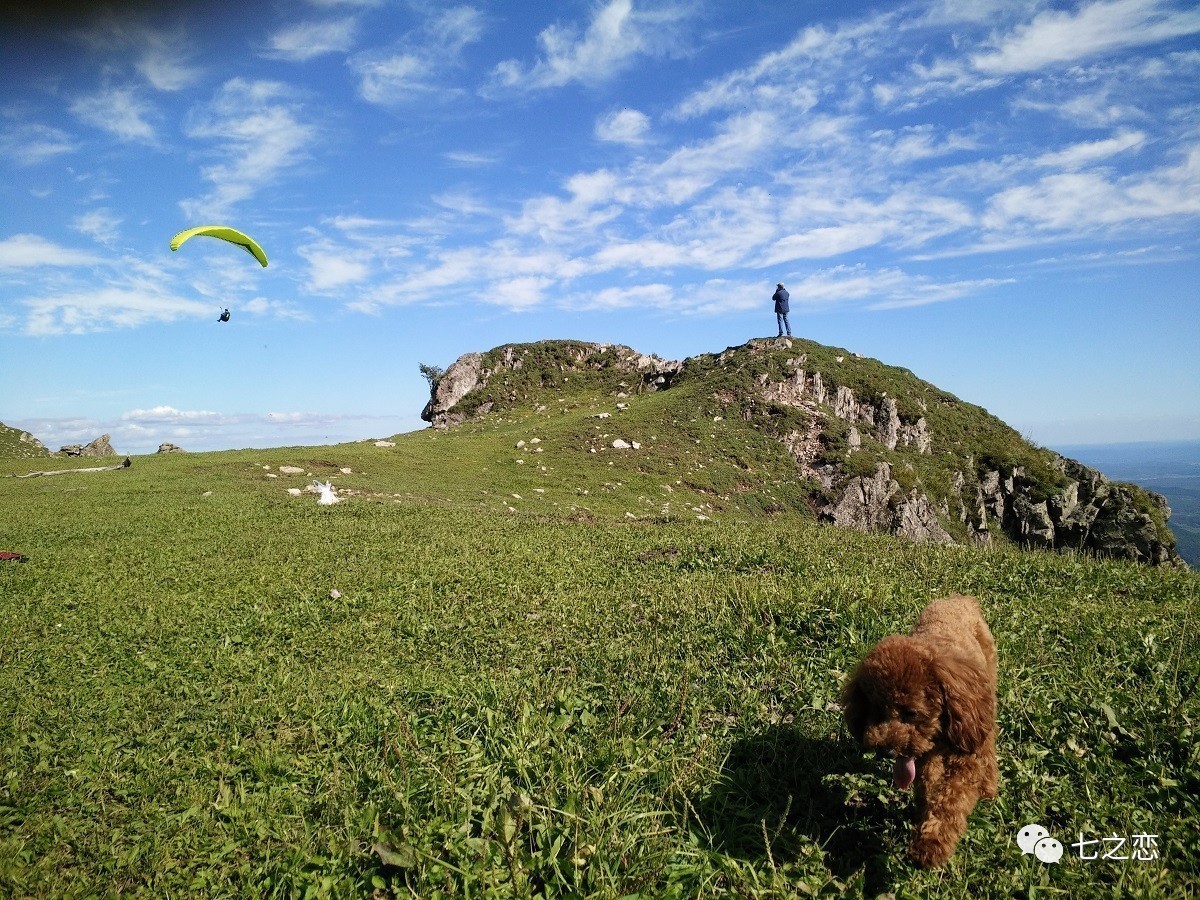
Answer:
[7,420,1200,898]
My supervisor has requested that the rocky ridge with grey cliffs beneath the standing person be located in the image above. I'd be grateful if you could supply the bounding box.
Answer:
[421,338,1182,565]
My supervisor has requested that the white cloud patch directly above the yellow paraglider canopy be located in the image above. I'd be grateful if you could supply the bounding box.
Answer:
[180,78,318,220]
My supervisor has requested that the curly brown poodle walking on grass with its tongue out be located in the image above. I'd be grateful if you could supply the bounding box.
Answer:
[841,594,1000,869]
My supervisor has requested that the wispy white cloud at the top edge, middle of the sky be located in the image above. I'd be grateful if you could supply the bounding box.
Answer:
[492,0,692,90]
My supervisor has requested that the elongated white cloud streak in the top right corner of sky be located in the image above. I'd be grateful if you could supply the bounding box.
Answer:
[972,0,1200,74]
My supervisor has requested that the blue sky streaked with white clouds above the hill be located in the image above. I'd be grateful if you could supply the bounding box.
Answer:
[0,0,1200,452]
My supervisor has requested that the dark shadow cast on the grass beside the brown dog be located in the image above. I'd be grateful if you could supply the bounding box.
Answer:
[694,726,907,895]
